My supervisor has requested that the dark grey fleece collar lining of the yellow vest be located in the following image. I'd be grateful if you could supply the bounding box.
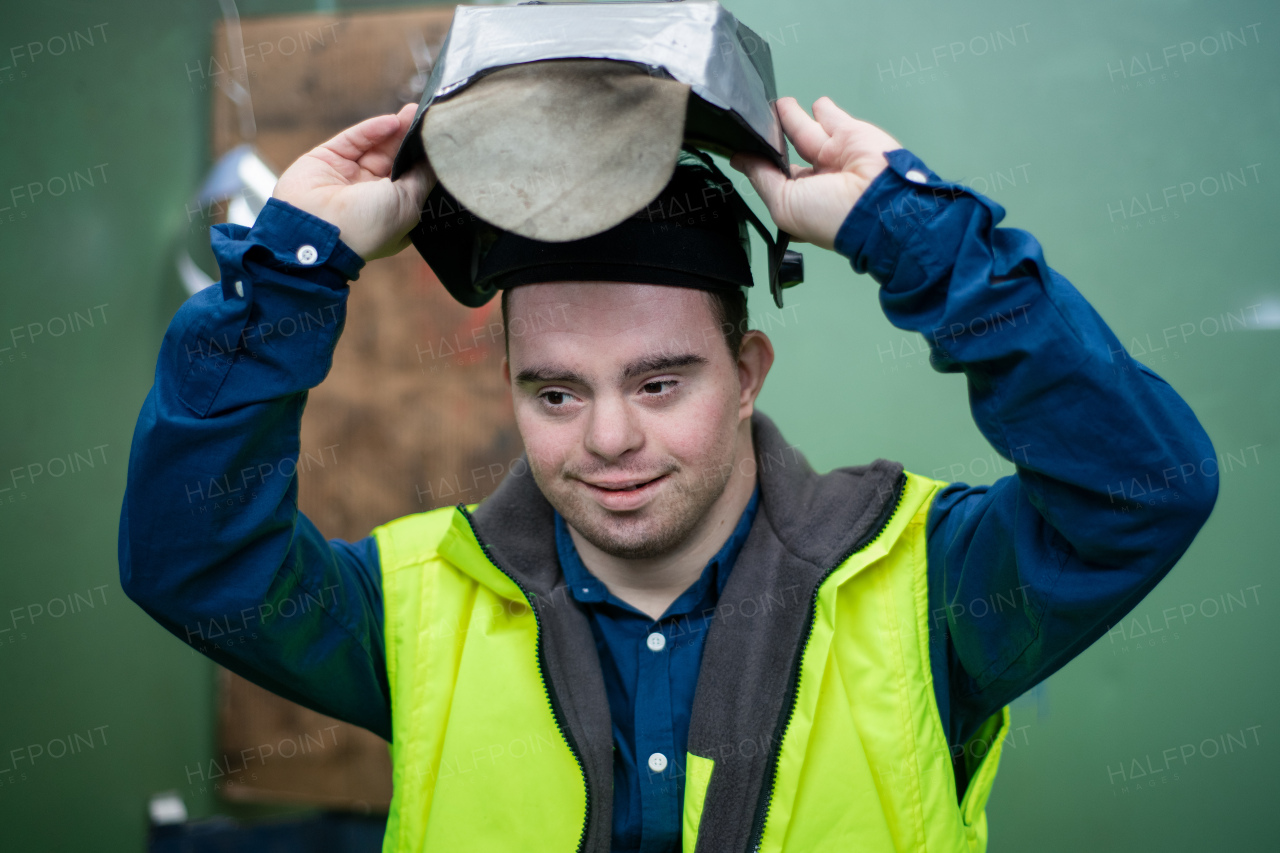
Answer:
[471,412,902,853]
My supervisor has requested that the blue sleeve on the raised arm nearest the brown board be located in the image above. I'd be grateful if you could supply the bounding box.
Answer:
[119,200,390,739]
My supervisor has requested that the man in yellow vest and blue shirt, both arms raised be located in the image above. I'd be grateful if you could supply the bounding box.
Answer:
[120,99,1217,852]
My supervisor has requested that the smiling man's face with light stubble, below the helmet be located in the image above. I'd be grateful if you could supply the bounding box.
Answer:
[506,282,758,558]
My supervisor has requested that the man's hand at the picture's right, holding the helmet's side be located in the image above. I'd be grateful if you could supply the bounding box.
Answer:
[730,96,902,248]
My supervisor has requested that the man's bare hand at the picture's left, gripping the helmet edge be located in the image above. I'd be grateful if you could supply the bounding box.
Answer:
[271,104,435,261]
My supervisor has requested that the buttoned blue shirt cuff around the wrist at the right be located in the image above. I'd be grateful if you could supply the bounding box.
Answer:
[836,149,1004,291]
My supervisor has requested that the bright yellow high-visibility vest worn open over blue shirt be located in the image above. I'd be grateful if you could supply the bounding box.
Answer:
[375,474,1009,853]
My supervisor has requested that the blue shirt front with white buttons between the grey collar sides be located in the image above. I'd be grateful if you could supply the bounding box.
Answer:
[556,487,760,853]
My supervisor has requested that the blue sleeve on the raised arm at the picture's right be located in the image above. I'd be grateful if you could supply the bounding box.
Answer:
[836,150,1217,744]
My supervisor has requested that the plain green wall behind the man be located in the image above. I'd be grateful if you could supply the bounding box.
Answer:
[0,0,1280,853]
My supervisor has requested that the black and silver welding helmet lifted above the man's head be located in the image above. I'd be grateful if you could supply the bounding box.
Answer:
[392,0,803,307]
